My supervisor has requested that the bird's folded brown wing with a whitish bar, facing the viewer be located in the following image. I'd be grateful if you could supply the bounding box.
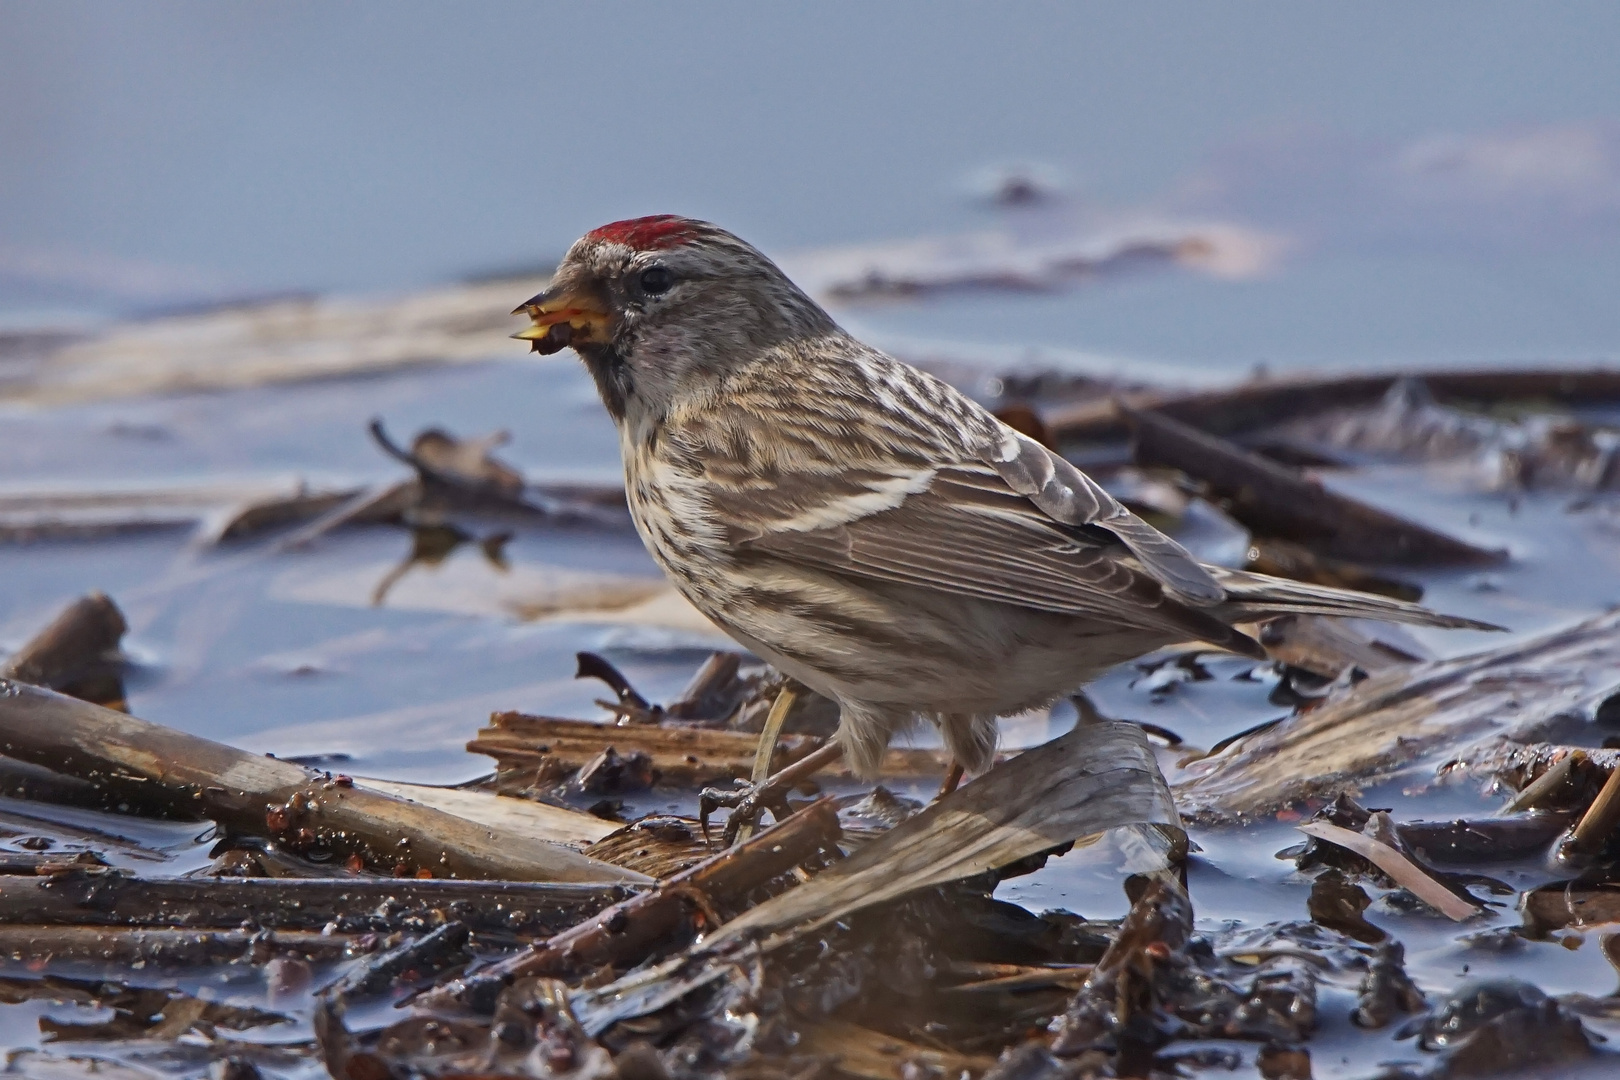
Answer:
[729,461,1259,653]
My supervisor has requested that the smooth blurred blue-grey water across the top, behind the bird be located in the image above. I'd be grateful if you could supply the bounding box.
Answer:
[0,0,1620,367]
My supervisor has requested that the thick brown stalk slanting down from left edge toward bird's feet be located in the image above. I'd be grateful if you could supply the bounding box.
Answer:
[0,680,646,882]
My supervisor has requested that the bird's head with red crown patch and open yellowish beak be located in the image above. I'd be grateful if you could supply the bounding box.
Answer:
[512,215,838,421]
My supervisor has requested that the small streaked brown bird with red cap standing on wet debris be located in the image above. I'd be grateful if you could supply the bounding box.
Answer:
[514,215,1487,829]
